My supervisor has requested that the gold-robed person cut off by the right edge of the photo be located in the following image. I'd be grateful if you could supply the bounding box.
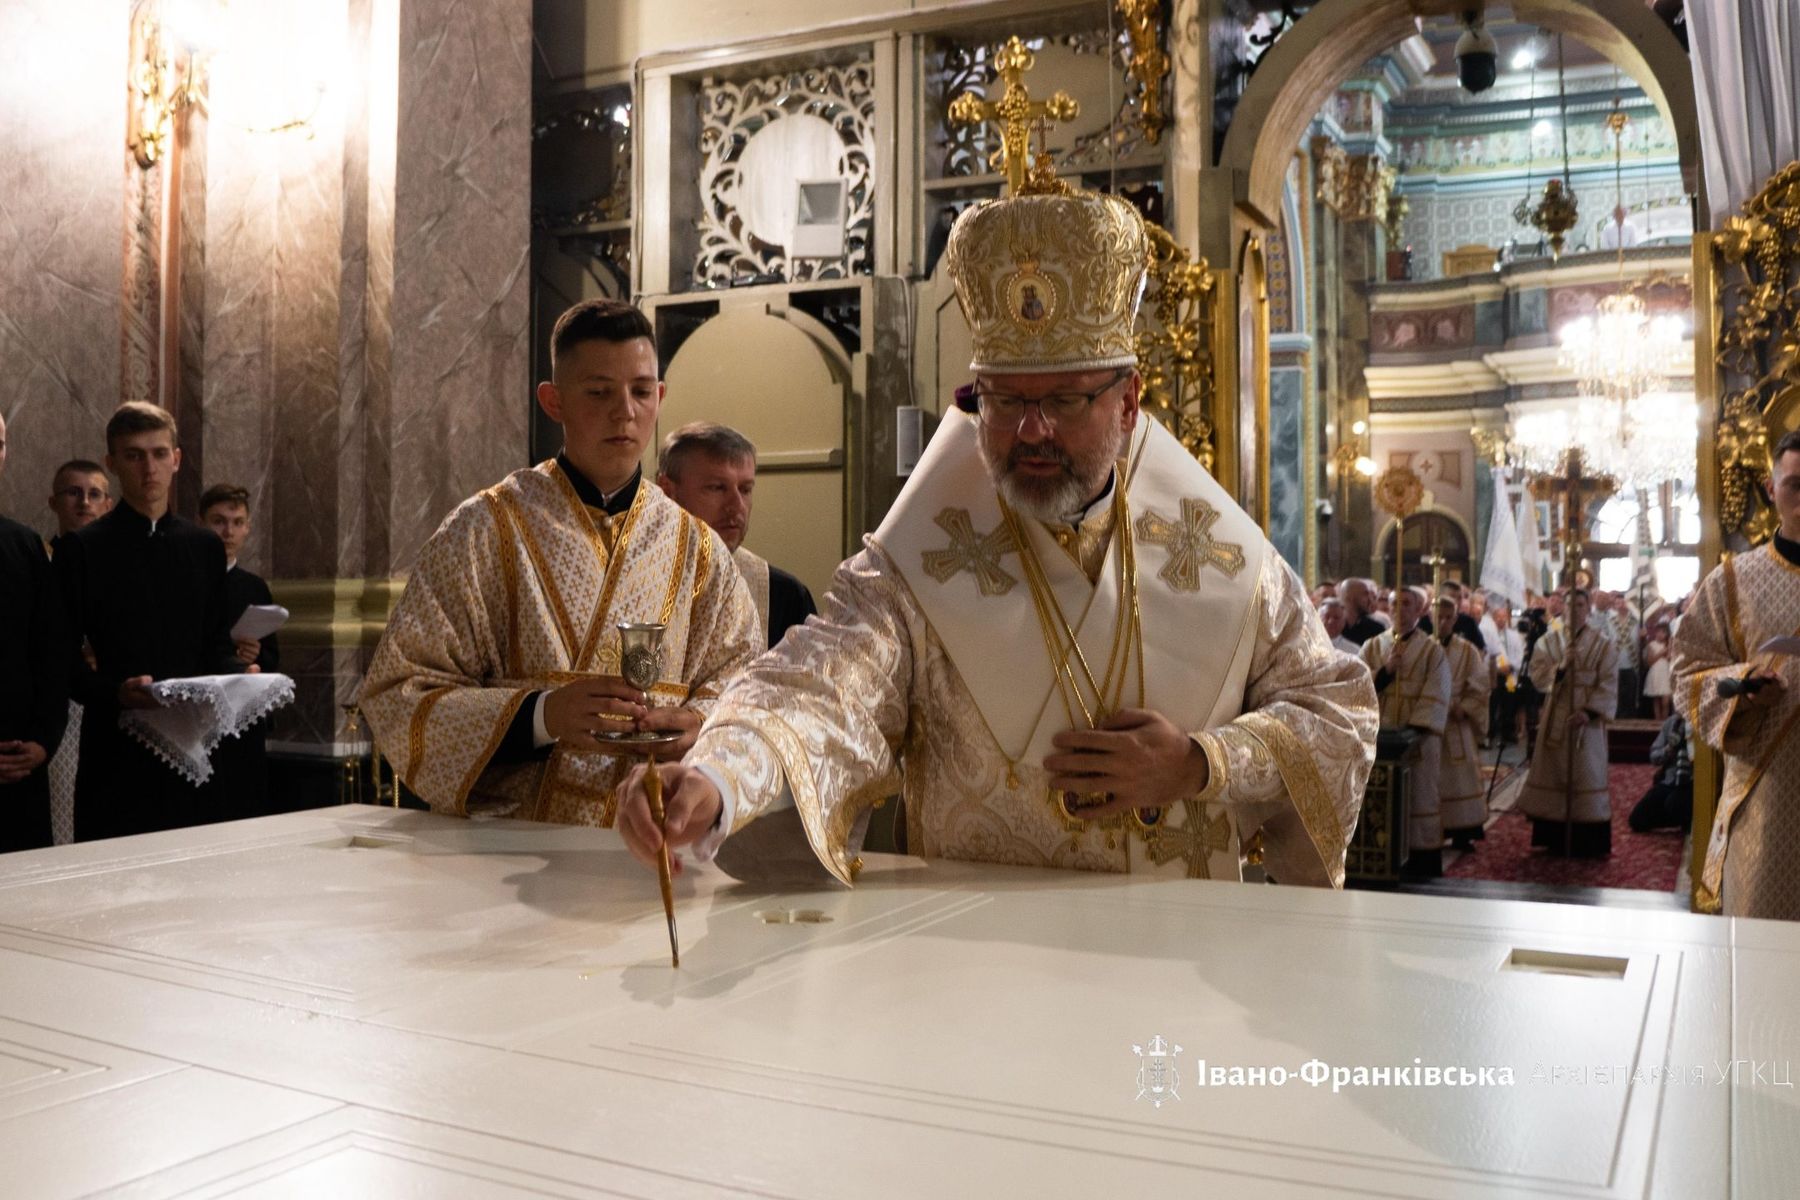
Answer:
[1674,434,1800,921]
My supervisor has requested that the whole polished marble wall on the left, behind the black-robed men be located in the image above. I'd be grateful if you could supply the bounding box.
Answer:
[0,0,531,750]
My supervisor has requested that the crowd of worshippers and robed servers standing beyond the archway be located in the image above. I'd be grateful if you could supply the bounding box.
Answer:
[1312,578,1694,876]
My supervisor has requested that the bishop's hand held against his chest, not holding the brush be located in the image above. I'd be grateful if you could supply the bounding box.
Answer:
[1044,709,1210,819]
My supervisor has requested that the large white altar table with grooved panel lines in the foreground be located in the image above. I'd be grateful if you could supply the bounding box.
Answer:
[0,806,1800,1200]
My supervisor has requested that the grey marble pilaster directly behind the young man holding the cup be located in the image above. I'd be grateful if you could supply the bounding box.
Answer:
[389,0,531,570]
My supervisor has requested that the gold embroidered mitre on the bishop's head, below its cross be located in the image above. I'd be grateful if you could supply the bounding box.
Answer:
[943,191,1150,374]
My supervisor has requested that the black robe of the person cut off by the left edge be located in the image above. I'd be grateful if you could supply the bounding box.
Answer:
[0,516,68,851]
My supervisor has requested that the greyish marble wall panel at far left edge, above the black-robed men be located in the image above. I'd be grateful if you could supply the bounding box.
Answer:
[0,0,128,533]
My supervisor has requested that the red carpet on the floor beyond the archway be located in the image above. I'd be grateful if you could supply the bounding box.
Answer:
[1444,763,1687,892]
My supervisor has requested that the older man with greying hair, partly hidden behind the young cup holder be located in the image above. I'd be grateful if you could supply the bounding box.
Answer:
[657,421,819,649]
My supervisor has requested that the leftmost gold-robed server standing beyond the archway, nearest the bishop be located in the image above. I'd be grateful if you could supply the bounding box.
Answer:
[1363,588,1451,876]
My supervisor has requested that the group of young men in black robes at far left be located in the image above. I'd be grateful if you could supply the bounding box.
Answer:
[0,401,281,851]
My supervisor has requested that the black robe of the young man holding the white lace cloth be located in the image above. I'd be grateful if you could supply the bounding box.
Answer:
[56,504,243,842]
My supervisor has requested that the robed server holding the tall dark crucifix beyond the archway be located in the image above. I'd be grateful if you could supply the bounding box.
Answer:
[1519,588,1618,858]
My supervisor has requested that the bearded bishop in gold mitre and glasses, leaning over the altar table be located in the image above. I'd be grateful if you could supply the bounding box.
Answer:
[619,180,1375,887]
